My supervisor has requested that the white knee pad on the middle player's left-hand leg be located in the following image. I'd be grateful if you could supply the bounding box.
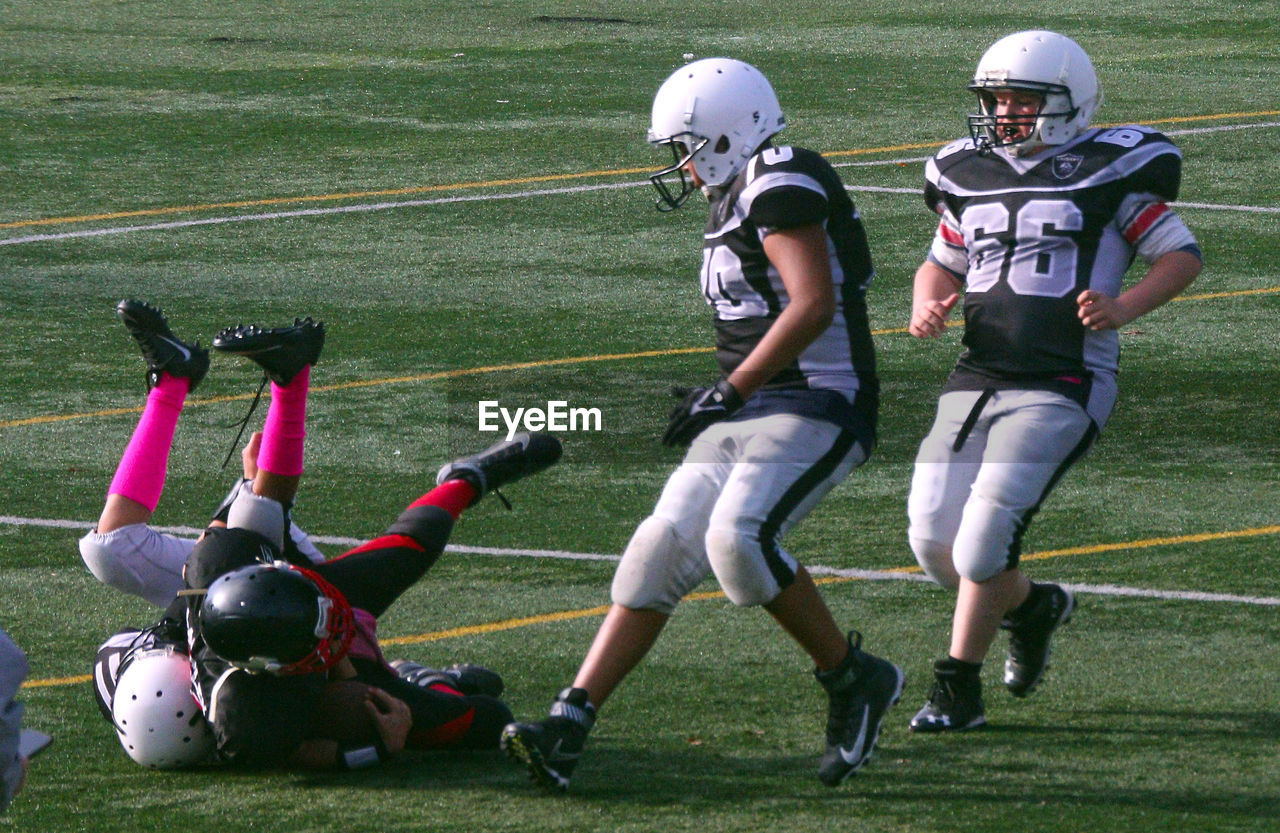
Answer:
[611,516,709,615]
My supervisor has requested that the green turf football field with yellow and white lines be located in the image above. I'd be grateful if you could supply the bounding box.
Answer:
[0,0,1280,833]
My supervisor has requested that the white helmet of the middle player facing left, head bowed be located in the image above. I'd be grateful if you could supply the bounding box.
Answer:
[649,58,787,211]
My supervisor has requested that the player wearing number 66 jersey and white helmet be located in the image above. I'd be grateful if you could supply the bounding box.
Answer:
[908,31,1202,732]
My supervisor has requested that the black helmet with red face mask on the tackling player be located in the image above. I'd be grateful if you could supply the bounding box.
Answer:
[198,560,356,676]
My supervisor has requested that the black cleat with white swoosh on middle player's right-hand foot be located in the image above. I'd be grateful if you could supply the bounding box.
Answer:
[814,632,905,787]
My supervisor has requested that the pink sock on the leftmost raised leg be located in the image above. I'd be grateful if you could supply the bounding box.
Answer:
[106,372,191,512]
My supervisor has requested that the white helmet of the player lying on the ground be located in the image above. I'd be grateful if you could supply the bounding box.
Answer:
[111,647,214,769]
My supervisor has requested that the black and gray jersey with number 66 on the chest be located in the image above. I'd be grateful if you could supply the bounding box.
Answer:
[924,125,1198,425]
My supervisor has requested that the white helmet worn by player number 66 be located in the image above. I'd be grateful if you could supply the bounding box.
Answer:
[969,29,1102,154]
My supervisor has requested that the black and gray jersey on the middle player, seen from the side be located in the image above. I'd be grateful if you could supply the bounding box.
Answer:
[701,146,878,429]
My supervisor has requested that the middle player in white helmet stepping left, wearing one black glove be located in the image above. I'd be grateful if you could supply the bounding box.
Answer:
[502,58,902,791]
